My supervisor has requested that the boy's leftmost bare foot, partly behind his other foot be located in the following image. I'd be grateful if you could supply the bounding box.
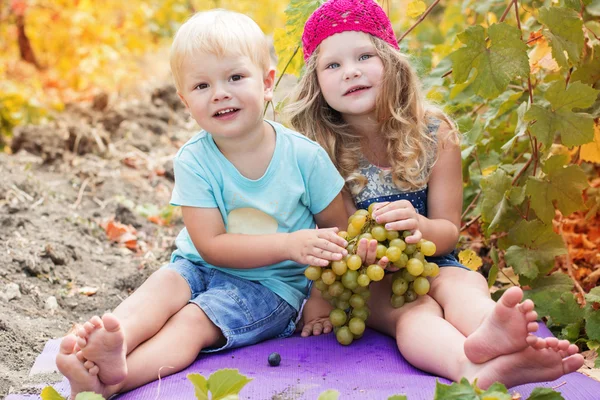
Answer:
[56,334,108,399]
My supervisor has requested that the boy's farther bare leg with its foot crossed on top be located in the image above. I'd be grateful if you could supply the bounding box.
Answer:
[77,269,190,385]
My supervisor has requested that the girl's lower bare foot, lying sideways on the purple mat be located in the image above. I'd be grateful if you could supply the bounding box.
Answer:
[466,340,583,389]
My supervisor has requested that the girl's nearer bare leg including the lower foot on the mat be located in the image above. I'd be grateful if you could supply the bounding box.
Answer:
[367,276,583,387]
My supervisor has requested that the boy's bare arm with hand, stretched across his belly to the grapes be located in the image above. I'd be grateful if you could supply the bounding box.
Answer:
[181,207,346,268]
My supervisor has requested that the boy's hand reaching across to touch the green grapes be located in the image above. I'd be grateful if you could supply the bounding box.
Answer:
[286,228,348,267]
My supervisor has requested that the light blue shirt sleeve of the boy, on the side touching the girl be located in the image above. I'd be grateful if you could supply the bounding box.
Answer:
[306,147,344,214]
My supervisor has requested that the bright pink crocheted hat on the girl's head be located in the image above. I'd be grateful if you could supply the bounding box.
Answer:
[302,0,399,61]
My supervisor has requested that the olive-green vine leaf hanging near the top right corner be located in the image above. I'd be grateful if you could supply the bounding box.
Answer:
[538,7,584,68]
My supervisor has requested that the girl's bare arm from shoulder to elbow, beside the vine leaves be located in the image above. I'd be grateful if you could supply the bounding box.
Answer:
[417,122,463,255]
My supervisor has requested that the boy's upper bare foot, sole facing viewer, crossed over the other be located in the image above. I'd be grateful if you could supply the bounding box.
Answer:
[77,313,127,385]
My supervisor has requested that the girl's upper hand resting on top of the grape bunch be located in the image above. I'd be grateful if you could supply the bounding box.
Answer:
[372,200,423,243]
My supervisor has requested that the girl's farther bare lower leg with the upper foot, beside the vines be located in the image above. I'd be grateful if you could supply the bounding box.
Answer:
[430,267,545,363]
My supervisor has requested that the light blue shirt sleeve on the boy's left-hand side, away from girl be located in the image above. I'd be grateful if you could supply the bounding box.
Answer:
[170,156,217,208]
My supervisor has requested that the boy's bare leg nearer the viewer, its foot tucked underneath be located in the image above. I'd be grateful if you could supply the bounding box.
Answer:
[57,304,224,398]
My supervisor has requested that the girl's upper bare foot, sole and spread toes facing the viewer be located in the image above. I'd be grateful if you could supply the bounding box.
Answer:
[465,287,547,364]
